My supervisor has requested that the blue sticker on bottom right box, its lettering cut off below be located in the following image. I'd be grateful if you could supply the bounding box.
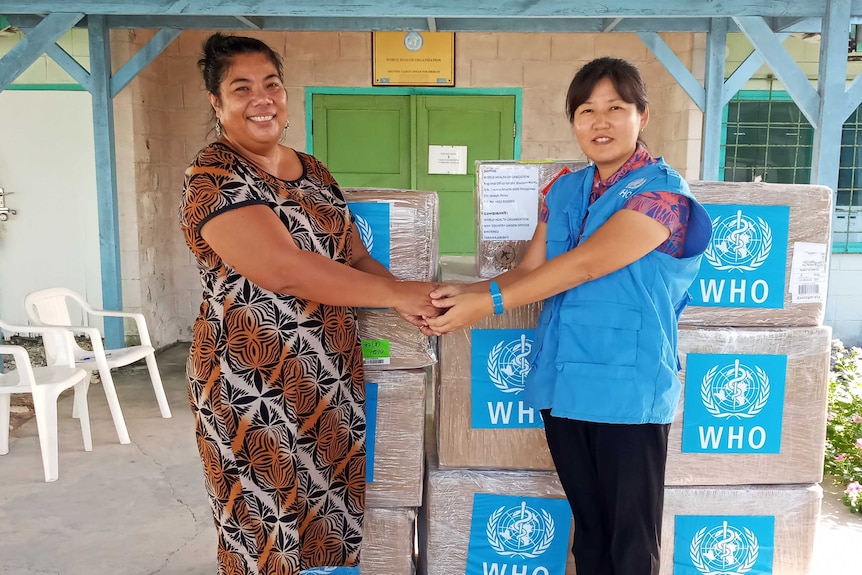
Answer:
[673,515,775,575]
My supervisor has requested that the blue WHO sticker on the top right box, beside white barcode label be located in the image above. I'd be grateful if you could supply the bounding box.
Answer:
[691,204,790,308]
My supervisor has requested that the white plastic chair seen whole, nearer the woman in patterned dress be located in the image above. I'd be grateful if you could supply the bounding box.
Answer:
[24,288,171,443]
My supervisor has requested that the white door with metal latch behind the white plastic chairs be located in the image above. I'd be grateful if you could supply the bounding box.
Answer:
[0,90,102,324]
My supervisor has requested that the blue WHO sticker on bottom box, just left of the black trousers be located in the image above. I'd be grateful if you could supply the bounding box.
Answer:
[465,493,572,575]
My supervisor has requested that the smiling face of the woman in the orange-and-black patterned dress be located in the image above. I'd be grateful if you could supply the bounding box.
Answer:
[209,52,287,154]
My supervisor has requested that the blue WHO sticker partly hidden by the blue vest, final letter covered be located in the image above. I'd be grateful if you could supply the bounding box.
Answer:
[470,329,542,429]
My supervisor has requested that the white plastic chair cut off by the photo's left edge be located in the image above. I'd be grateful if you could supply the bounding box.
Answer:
[0,321,93,482]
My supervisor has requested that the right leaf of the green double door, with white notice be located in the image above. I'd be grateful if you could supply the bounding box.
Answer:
[414,96,515,255]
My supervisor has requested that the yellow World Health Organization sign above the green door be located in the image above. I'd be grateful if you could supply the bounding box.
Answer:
[372,31,455,86]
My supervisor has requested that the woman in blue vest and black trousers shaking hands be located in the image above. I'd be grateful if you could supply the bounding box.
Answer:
[427,58,711,575]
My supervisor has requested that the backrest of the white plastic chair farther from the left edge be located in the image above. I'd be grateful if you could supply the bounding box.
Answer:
[24,288,86,365]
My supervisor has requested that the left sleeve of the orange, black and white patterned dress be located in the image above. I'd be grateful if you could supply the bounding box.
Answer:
[180,146,267,235]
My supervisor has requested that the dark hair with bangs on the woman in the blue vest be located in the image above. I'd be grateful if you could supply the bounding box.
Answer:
[566,56,649,123]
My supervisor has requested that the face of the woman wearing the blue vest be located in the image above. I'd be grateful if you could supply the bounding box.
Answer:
[572,77,649,180]
